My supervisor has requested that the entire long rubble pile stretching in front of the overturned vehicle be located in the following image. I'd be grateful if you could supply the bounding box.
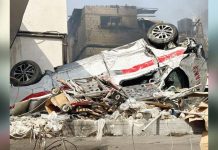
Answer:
[10,77,208,139]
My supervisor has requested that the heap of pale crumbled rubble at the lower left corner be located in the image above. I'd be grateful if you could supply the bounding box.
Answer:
[10,112,69,138]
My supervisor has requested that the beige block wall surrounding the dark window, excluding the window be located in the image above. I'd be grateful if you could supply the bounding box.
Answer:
[69,6,143,61]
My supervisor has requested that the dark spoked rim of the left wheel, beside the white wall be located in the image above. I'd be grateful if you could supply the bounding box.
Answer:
[13,63,35,82]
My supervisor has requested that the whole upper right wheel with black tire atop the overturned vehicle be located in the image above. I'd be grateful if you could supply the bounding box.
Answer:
[147,23,178,48]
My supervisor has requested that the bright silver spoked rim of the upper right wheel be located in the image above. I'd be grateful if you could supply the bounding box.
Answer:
[151,25,173,39]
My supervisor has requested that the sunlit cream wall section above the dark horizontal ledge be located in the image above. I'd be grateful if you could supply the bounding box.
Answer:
[20,0,67,33]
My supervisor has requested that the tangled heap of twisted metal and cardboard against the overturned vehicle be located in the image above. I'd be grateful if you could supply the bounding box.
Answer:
[45,77,126,119]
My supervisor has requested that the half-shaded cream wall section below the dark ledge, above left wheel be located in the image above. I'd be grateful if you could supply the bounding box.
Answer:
[11,37,63,72]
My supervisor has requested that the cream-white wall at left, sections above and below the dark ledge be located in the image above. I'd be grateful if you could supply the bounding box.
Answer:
[11,0,67,71]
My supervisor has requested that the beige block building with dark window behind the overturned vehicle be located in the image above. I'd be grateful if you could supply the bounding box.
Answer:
[68,6,146,61]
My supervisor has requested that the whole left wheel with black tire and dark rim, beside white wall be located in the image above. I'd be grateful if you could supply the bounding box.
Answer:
[10,60,42,86]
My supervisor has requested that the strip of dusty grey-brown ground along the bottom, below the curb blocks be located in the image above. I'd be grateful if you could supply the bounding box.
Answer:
[10,135,201,150]
